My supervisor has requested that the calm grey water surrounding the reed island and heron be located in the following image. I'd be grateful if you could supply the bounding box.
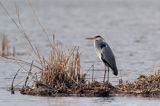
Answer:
[0,0,160,106]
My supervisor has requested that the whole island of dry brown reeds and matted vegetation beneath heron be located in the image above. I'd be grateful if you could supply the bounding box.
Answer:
[7,36,160,97]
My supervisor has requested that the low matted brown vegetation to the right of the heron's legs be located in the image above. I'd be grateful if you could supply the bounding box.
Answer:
[117,71,160,96]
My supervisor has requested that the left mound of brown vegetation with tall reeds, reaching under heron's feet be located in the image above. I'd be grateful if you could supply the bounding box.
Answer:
[20,37,114,96]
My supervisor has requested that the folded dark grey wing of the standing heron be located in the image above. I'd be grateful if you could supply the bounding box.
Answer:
[101,45,118,75]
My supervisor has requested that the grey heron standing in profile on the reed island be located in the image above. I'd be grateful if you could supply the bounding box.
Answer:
[86,35,118,83]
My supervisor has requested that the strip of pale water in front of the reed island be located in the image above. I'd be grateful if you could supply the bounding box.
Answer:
[0,90,160,106]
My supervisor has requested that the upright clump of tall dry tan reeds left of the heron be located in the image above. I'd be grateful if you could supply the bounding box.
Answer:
[40,37,85,92]
